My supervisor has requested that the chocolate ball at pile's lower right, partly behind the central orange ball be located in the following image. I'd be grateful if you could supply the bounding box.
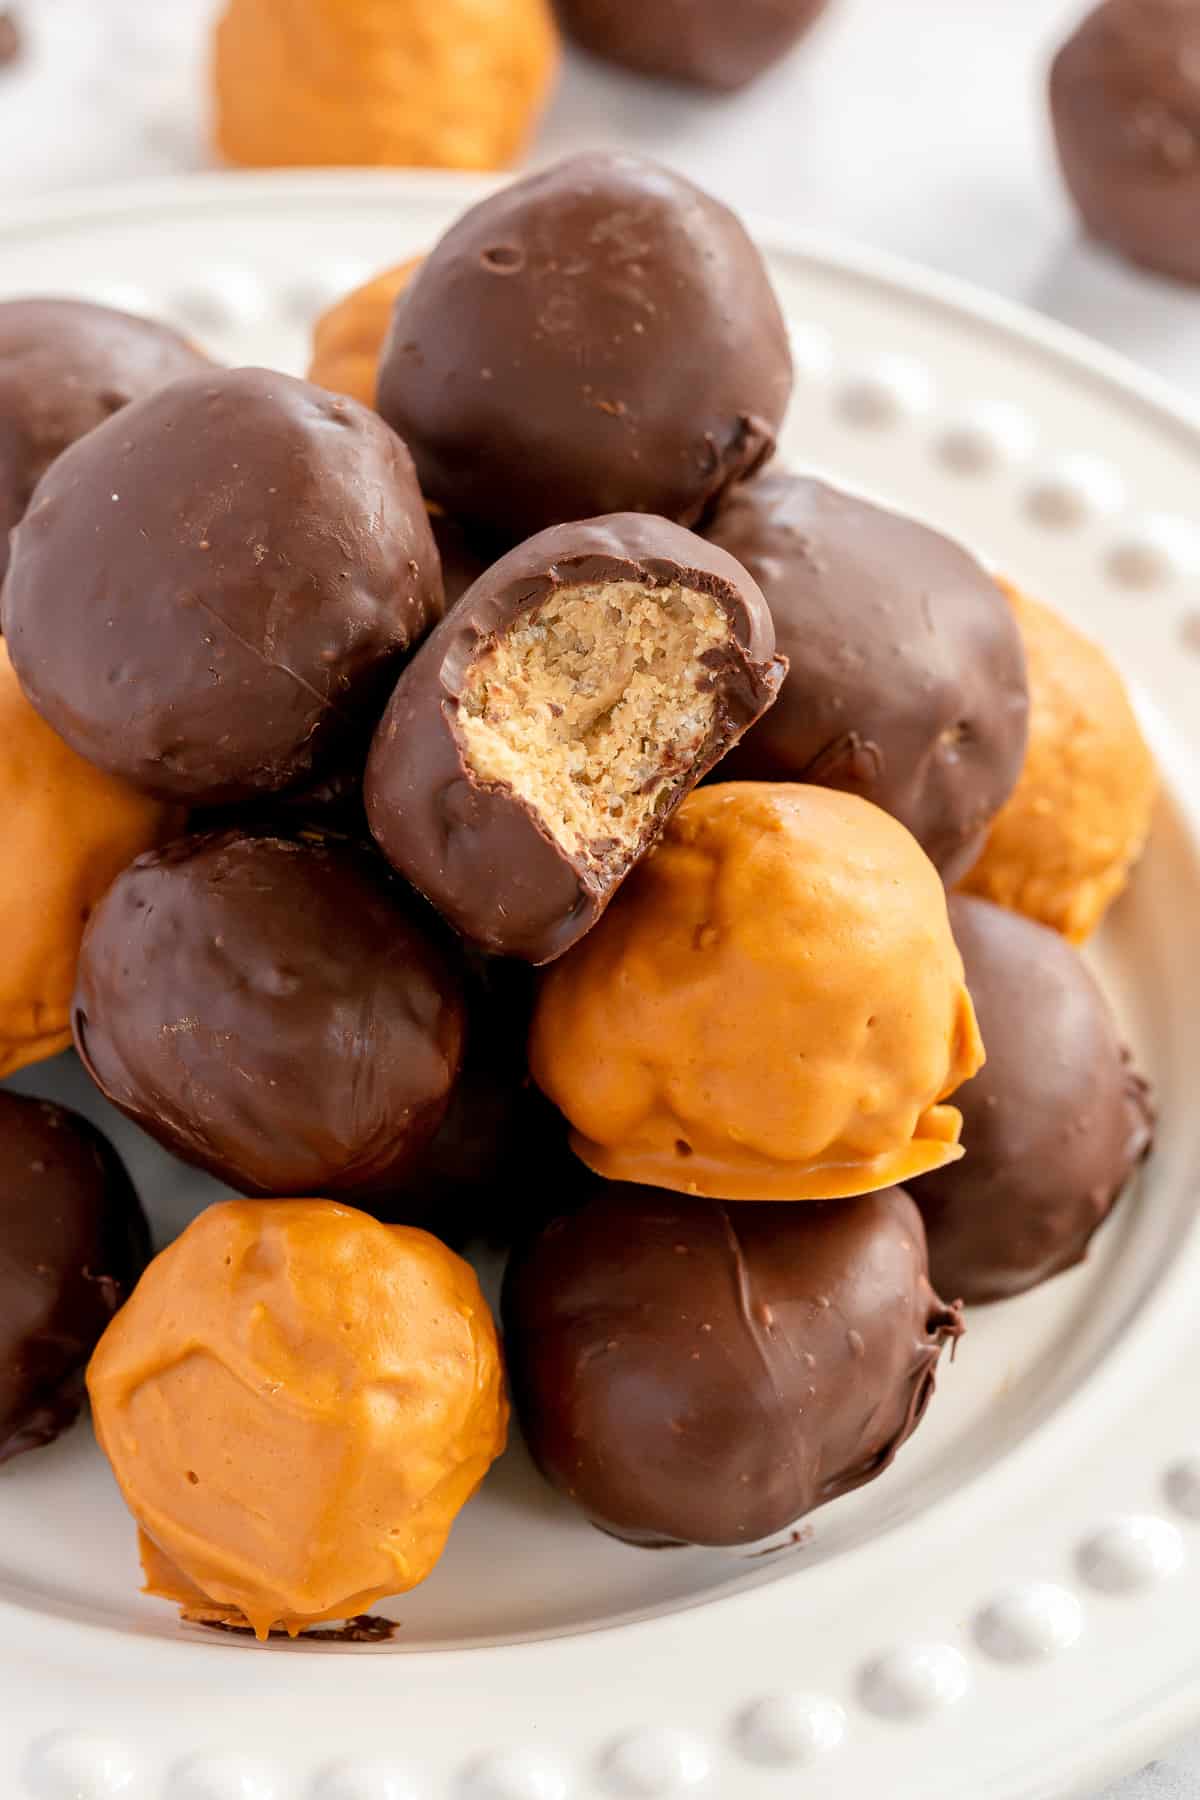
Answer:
[912,895,1153,1301]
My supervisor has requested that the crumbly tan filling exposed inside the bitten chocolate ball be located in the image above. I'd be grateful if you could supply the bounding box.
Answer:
[459,581,732,869]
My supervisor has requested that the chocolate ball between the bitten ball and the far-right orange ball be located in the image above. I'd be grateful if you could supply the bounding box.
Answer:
[707,472,1029,884]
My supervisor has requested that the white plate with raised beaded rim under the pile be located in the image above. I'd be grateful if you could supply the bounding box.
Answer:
[0,175,1200,1800]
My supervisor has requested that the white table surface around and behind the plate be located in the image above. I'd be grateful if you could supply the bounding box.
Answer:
[0,0,1200,1800]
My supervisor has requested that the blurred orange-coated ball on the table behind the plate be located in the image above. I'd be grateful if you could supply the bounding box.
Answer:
[212,0,560,169]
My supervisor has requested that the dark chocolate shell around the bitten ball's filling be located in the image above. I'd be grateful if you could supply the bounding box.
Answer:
[363,513,783,963]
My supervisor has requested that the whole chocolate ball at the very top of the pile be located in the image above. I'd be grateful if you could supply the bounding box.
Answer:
[378,153,792,544]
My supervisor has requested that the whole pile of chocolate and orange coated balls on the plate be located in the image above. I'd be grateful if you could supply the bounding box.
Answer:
[0,155,1155,1636]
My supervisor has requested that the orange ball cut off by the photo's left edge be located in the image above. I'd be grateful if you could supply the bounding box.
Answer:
[0,641,178,1076]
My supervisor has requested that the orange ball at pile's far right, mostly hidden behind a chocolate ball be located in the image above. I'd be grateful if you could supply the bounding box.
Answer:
[963,583,1159,943]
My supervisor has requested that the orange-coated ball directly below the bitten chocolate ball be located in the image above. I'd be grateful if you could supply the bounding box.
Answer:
[529,781,982,1201]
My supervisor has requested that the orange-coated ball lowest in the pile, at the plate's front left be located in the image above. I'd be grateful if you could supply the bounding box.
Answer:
[88,1201,507,1638]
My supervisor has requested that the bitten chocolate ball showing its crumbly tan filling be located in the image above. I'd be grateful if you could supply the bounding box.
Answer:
[363,513,783,963]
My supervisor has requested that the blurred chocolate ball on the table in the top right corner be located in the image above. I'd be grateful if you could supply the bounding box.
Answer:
[1051,0,1200,281]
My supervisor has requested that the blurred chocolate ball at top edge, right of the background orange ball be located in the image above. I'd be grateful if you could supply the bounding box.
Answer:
[558,0,826,92]
